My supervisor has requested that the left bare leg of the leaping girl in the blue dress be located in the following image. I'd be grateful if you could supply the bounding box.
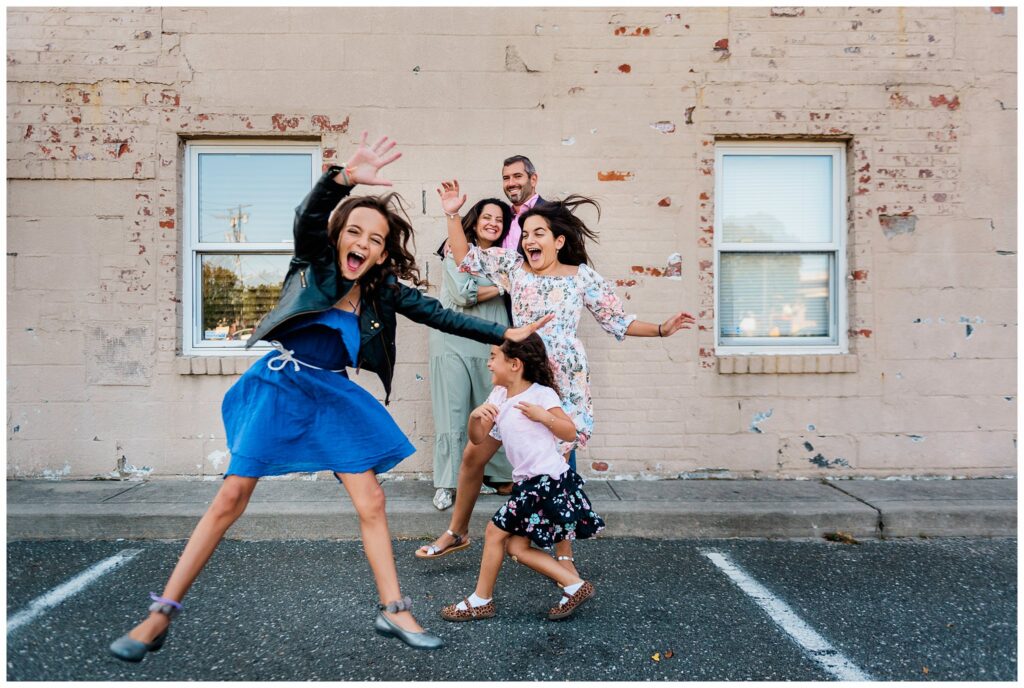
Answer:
[128,475,257,643]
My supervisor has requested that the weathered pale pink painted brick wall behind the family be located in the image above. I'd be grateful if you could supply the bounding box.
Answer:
[7,7,1017,477]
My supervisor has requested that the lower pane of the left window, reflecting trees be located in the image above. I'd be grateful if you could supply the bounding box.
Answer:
[200,254,292,342]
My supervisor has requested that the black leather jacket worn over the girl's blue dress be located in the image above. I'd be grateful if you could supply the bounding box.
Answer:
[246,167,505,403]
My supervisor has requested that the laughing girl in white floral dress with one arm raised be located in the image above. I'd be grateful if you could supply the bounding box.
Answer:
[420,180,693,573]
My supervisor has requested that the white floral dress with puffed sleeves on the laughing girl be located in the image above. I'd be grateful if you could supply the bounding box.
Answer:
[459,246,637,454]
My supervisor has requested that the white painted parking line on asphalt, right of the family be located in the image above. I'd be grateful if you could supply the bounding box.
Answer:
[700,552,873,681]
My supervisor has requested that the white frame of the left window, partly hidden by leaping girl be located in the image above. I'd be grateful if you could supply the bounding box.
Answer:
[181,139,323,356]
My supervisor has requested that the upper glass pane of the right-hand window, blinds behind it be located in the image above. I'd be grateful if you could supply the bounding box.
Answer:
[719,155,833,243]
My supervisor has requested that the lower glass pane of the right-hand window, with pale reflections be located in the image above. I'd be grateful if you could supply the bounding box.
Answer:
[719,253,831,343]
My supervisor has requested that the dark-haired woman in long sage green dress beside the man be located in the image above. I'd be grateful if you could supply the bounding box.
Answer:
[430,199,512,511]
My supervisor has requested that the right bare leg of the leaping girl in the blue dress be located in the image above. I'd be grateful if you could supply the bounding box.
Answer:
[335,471,423,633]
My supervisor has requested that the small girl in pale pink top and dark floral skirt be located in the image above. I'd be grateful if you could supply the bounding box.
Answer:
[441,334,604,621]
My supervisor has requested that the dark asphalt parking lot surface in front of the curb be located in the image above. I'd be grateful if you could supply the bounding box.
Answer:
[7,539,1017,681]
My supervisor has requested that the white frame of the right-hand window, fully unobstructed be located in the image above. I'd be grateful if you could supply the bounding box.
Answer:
[714,141,849,355]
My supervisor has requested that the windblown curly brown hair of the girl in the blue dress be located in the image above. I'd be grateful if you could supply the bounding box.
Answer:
[327,191,426,293]
